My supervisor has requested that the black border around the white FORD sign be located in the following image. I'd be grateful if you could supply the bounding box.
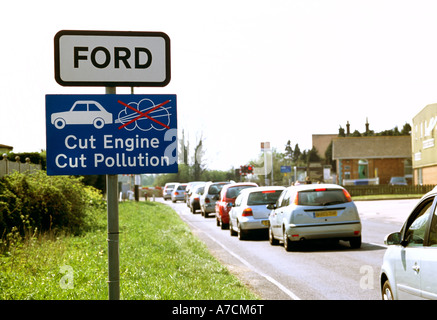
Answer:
[55,30,171,87]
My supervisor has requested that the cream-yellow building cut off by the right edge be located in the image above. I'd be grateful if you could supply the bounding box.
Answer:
[411,103,437,185]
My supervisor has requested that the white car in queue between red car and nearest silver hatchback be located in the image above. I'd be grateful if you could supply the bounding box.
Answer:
[228,187,285,240]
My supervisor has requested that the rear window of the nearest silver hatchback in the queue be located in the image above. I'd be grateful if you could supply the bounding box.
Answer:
[298,189,348,206]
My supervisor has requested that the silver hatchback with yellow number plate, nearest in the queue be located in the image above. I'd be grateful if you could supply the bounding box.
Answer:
[269,184,361,251]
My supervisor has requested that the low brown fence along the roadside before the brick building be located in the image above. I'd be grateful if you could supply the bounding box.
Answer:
[345,185,435,197]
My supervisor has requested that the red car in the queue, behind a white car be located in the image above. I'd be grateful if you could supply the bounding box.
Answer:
[215,182,258,229]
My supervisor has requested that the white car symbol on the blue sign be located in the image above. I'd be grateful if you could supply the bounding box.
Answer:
[51,100,113,129]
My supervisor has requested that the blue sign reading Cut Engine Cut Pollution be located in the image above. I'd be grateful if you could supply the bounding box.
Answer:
[46,94,178,175]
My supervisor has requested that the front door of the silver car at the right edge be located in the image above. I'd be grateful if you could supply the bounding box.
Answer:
[395,197,434,300]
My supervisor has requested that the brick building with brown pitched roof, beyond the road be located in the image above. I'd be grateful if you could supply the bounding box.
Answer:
[332,136,412,185]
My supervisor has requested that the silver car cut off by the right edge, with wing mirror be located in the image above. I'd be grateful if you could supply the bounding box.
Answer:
[380,187,437,300]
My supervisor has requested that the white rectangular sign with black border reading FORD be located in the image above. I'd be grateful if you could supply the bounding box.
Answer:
[55,30,171,87]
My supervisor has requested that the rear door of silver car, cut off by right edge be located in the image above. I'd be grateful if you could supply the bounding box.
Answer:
[419,202,437,300]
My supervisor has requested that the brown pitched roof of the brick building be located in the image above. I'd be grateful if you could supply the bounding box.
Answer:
[332,136,411,160]
